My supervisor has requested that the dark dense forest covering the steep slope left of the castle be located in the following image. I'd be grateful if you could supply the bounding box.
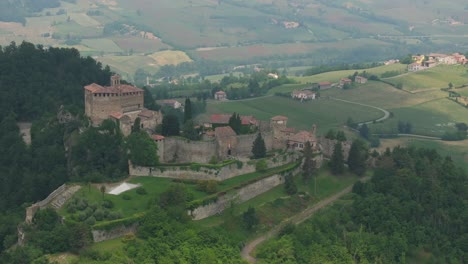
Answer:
[0,42,114,256]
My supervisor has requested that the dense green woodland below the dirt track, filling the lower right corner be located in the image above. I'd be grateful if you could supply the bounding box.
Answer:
[257,148,468,263]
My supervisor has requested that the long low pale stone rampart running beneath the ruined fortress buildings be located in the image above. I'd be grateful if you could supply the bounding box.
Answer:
[129,152,300,181]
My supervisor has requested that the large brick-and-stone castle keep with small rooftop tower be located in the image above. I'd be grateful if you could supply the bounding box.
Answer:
[84,75,162,135]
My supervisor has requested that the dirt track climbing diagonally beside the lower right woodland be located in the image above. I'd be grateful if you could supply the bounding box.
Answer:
[241,177,370,263]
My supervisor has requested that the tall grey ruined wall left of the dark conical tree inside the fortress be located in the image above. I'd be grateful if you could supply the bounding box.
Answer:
[158,137,217,163]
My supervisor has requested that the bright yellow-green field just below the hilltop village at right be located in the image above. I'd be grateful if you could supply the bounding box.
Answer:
[385,65,468,91]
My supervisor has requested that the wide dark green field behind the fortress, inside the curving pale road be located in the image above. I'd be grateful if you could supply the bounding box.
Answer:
[207,96,383,133]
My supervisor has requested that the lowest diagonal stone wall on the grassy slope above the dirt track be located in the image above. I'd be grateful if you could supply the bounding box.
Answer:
[188,174,294,220]
